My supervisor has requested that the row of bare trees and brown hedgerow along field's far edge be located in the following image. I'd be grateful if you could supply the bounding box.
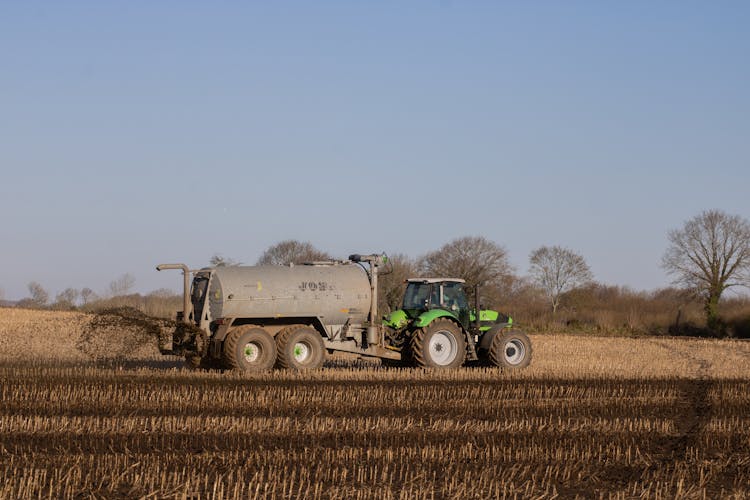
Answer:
[10,210,750,336]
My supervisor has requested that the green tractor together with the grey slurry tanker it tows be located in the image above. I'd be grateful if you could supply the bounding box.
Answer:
[157,254,532,371]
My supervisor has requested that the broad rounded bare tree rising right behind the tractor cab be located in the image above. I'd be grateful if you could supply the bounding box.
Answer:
[419,236,513,301]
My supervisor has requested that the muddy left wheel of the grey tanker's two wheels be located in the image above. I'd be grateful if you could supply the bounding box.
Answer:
[224,325,276,372]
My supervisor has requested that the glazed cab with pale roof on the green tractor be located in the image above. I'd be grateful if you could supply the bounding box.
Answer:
[402,278,470,327]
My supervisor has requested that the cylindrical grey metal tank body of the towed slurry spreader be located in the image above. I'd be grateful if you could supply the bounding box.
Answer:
[209,263,370,325]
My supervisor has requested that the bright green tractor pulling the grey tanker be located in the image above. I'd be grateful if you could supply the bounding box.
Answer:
[383,278,531,369]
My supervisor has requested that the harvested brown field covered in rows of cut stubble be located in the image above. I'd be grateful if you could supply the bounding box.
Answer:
[0,310,750,498]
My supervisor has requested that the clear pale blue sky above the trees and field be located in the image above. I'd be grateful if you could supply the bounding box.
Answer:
[0,1,750,299]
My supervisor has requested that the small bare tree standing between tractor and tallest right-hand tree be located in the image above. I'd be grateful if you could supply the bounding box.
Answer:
[529,246,593,314]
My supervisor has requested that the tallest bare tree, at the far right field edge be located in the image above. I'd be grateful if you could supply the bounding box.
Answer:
[662,210,750,330]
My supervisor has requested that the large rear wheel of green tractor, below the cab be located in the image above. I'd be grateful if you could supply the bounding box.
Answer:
[409,319,466,369]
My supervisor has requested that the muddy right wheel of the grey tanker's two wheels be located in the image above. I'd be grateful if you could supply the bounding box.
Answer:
[276,325,326,370]
